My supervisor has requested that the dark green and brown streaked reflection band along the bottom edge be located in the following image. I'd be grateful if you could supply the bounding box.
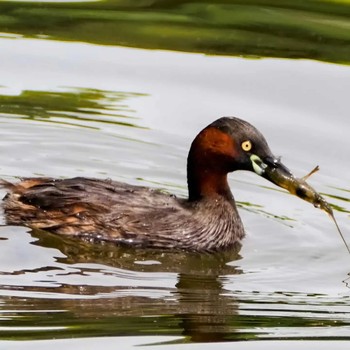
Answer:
[0,290,350,344]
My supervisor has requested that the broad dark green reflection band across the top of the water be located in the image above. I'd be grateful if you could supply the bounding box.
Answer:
[0,0,350,63]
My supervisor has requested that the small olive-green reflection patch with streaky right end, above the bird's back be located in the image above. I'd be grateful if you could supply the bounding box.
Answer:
[0,88,144,129]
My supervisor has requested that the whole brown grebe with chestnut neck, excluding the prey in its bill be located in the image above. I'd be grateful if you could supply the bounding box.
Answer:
[0,117,308,251]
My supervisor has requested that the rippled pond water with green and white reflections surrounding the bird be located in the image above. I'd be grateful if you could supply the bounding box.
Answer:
[0,1,350,350]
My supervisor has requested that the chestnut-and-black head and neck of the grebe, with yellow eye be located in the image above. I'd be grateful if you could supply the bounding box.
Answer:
[187,117,293,201]
